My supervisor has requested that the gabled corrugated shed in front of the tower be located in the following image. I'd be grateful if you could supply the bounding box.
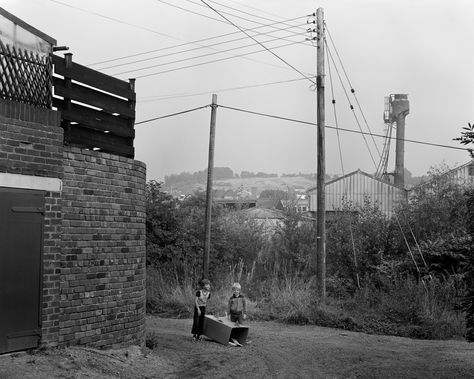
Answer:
[307,170,407,217]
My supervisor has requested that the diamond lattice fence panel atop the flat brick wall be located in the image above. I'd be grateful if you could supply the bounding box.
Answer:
[0,40,52,108]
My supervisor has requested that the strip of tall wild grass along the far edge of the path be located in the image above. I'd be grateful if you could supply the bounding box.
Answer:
[147,267,466,339]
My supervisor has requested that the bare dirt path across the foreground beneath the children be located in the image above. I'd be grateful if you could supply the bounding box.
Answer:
[0,317,474,379]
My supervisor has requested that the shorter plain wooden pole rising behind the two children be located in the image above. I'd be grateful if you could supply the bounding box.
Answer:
[202,94,217,278]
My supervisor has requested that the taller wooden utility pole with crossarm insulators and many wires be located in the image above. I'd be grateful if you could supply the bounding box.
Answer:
[316,8,326,300]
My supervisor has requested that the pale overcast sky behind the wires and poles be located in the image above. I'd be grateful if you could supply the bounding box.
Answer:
[0,0,474,181]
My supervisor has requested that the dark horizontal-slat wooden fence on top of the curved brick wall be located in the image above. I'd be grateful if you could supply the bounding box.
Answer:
[52,54,136,158]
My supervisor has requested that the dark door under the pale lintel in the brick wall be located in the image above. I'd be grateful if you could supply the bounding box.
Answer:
[0,188,44,354]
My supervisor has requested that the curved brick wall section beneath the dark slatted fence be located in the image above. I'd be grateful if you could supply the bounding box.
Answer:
[59,147,146,347]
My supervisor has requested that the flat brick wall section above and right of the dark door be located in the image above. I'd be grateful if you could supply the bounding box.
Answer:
[0,100,63,345]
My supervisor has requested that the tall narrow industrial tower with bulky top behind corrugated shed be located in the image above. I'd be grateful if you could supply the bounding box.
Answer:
[383,94,410,188]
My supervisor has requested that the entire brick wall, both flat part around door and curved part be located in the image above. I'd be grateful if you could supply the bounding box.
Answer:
[0,100,146,347]
